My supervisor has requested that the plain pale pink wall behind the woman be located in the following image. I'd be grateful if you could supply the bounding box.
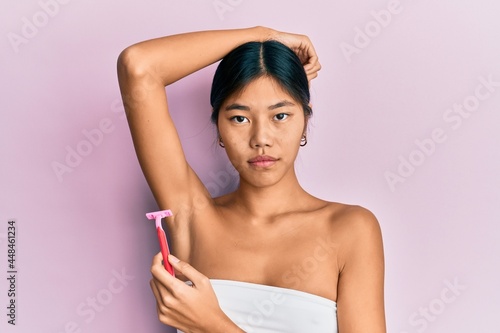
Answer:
[0,0,500,333]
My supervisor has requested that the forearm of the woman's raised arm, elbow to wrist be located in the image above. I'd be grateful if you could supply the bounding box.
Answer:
[118,27,273,86]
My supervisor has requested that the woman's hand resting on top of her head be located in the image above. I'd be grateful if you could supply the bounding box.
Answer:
[270,30,321,82]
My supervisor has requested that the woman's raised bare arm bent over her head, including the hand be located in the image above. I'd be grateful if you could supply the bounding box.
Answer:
[117,27,321,211]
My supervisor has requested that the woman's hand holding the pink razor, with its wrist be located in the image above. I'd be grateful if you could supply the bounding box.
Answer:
[150,253,242,332]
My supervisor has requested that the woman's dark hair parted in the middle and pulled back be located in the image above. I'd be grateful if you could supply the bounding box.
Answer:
[210,41,312,124]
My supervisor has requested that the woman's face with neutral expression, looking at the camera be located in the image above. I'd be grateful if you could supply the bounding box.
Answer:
[218,77,306,187]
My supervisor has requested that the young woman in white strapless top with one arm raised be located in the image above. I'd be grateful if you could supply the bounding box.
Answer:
[118,27,385,333]
